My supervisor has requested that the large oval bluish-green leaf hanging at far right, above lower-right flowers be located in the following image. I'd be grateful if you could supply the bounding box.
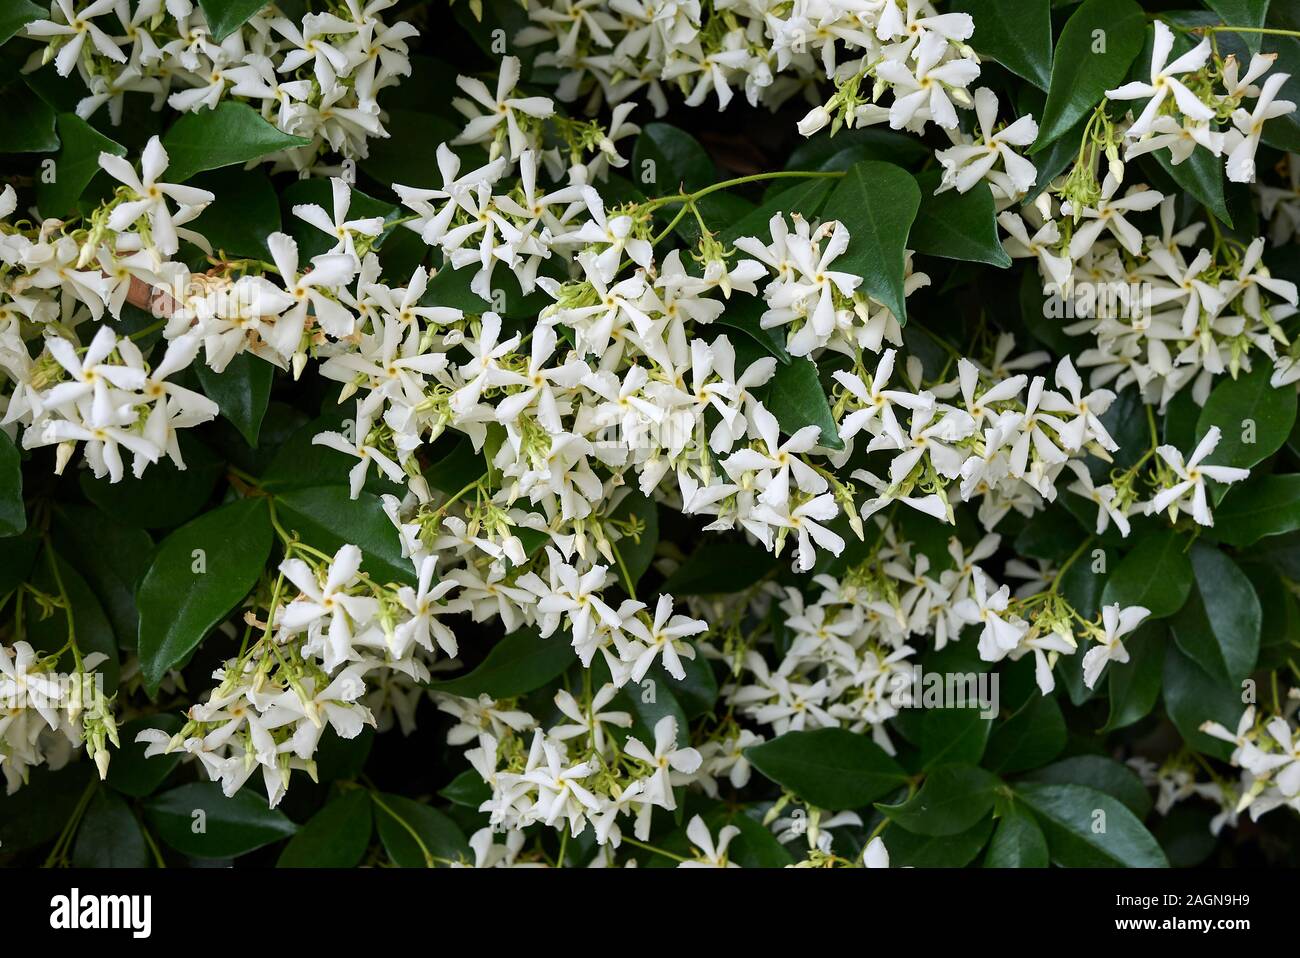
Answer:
[1170,542,1262,682]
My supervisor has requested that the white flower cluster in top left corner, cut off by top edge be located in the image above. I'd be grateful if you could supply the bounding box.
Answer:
[26,0,416,170]
